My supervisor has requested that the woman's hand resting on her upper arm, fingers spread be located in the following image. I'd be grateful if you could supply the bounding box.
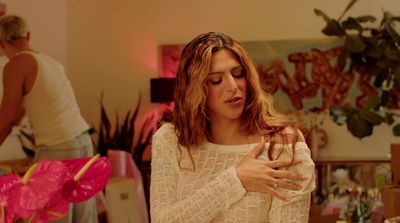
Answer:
[236,137,306,201]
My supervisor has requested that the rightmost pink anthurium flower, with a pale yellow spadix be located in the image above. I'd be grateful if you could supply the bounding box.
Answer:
[62,154,111,202]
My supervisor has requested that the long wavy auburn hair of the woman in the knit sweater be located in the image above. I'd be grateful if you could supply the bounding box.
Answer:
[172,32,298,162]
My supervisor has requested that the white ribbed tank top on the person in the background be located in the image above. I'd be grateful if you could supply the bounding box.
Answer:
[19,51,89,145]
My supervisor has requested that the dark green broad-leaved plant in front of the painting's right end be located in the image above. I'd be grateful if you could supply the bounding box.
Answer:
[314,0,400,138]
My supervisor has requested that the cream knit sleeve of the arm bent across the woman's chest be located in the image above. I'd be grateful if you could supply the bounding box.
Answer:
[150,124,246,223]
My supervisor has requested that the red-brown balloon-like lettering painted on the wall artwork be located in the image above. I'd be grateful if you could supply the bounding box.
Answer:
[257,47,376,110]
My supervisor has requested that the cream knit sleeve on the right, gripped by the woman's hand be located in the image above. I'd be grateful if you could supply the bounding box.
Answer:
[269,142,315,223]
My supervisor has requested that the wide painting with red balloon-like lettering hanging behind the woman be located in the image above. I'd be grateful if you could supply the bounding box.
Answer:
[160,39,400,110]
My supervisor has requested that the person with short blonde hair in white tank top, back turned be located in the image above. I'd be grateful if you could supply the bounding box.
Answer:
[0,15,97,223]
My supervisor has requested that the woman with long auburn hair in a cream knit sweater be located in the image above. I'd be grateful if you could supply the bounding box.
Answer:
[150,32,315,222]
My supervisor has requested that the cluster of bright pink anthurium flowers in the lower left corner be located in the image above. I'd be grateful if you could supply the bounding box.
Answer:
[0,155,110,223]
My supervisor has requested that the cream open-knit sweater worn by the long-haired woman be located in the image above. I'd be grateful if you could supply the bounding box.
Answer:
[150,124,315,223]
